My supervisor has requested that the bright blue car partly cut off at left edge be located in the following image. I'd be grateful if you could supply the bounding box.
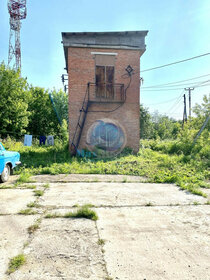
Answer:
[0,143,21,183]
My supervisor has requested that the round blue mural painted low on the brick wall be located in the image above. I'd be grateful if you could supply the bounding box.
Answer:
[86,119,126,156]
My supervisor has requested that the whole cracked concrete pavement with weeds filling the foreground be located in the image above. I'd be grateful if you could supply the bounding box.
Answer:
[0,174,210,280]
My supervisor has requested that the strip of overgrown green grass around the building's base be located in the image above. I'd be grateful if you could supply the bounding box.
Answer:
[1,138,210,196]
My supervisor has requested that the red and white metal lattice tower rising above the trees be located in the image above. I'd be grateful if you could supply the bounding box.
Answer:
[8,0,26,70]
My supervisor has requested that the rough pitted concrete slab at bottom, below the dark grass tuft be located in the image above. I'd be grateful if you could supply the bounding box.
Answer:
[8,218,107,280]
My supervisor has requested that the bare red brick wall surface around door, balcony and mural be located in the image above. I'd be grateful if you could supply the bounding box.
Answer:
[68,48,140,152]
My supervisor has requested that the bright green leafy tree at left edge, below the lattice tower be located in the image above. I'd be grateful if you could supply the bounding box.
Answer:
[0,63,30,137]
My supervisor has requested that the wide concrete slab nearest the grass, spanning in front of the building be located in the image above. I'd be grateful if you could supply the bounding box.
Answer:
[41,182,206,207]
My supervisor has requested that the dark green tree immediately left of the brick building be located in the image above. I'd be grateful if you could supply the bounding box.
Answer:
[28,86,60,136]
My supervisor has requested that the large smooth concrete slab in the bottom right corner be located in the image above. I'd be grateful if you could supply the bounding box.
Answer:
[97,205,210,280]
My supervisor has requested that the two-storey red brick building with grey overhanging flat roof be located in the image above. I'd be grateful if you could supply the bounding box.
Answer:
[62,31,148,156]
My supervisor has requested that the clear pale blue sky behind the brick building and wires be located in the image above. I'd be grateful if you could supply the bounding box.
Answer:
[0,0,210,118]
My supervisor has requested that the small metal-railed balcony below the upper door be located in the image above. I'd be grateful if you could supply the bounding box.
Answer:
[88,83,125,103]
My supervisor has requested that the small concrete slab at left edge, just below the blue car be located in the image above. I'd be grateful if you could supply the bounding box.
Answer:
[0,189,35,214]
